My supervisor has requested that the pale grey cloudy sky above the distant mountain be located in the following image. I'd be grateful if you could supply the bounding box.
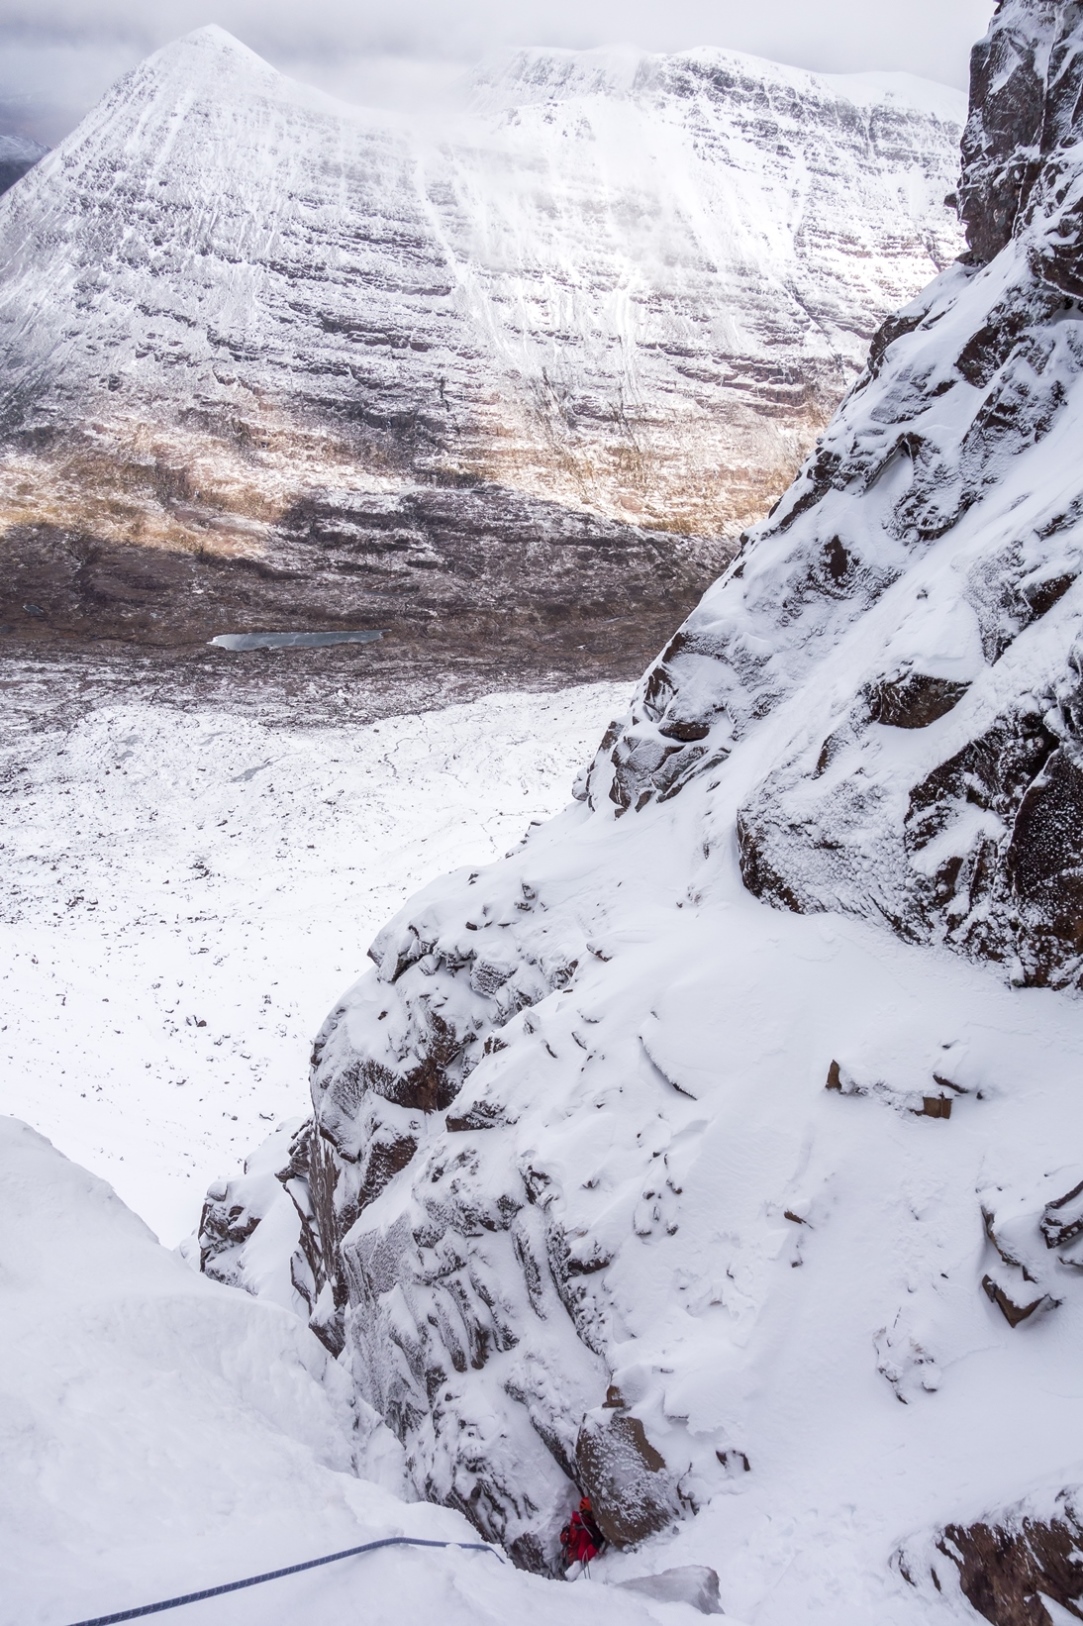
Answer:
[0,0,994,141]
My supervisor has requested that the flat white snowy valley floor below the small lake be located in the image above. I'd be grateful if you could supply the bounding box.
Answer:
[0,685,628,1244]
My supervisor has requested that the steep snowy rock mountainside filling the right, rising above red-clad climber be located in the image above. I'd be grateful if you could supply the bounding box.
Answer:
[202,0,1083,1626]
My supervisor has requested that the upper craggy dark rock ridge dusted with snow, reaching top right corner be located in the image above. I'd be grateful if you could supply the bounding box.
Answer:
[590,5,1083,984]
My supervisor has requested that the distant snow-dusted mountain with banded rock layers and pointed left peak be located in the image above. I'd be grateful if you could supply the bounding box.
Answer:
[0,28,964,647]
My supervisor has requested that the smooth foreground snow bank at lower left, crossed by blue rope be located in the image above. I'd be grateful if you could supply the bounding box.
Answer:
[0,1117,715,1626]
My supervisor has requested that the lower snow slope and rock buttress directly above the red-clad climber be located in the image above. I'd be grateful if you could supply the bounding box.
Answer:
[202,790,1083,1626]
